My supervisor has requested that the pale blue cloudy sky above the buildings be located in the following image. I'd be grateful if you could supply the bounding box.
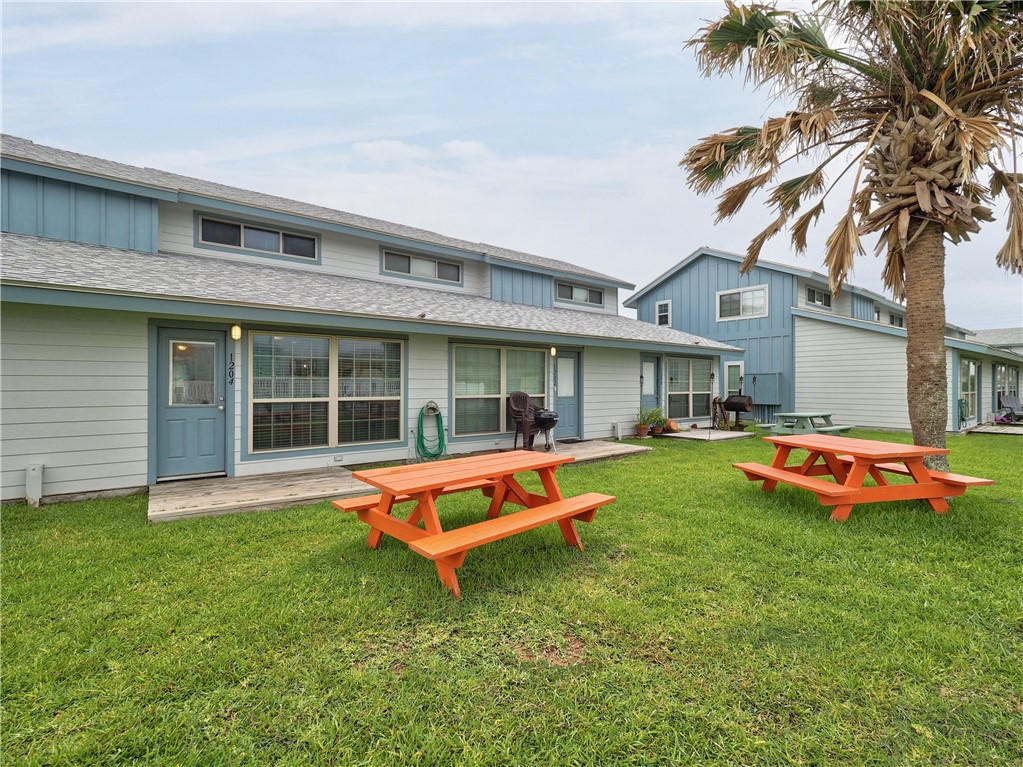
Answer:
[0,1,1023,329]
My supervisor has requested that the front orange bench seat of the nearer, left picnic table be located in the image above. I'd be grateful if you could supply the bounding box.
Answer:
[408,493,615,559]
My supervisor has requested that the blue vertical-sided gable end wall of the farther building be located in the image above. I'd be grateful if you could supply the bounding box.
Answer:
[636,255,793,418]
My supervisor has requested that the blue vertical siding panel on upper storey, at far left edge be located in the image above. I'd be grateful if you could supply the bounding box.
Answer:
[2,171,160,253]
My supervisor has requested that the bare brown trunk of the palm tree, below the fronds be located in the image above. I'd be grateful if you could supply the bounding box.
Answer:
[904,220,948,471]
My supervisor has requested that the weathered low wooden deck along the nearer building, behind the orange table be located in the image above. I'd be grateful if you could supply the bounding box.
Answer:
[148,440,651,523]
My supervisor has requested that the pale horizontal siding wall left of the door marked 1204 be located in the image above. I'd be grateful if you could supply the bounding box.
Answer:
[0,302,148,500]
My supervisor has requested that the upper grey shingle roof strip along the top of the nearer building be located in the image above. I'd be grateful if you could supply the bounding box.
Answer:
[0,134,635,288]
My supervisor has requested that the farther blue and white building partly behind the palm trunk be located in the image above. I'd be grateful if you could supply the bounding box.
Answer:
[624,247,1023,431]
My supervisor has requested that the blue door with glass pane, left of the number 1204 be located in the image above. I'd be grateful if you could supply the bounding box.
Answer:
[157,327,227,480]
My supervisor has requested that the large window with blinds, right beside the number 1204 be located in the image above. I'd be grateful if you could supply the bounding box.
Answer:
[250,333,403,452]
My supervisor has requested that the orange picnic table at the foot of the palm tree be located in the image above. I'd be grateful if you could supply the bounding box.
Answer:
[732,434,994,522]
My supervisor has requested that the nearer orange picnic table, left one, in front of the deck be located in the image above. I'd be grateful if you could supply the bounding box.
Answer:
[333,450,615,598]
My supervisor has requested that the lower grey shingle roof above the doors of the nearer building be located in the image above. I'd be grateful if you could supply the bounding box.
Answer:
[0,234,739,351]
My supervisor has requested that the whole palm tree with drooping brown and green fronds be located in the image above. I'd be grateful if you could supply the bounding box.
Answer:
[679,0,1023,464]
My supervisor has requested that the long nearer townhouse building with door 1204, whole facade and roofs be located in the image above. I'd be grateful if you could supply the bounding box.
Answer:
[0,136,742,511]
